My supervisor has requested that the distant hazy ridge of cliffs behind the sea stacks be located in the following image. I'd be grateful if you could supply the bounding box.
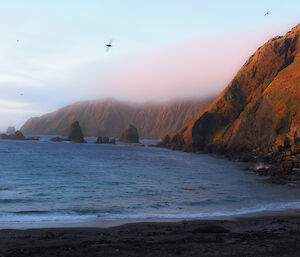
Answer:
[21,97,214,138]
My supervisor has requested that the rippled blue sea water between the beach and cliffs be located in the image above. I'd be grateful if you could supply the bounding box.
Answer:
[0,136,300,228]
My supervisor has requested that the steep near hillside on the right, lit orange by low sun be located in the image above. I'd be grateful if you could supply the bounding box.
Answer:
[171,25,300,151]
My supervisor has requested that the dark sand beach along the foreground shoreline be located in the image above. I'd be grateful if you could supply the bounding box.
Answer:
[0,211,300,257]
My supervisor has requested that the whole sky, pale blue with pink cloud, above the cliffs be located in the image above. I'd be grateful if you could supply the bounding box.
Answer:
[0,0,300,131]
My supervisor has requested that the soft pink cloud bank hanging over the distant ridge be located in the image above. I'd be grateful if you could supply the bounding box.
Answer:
[89,23,296,101]
